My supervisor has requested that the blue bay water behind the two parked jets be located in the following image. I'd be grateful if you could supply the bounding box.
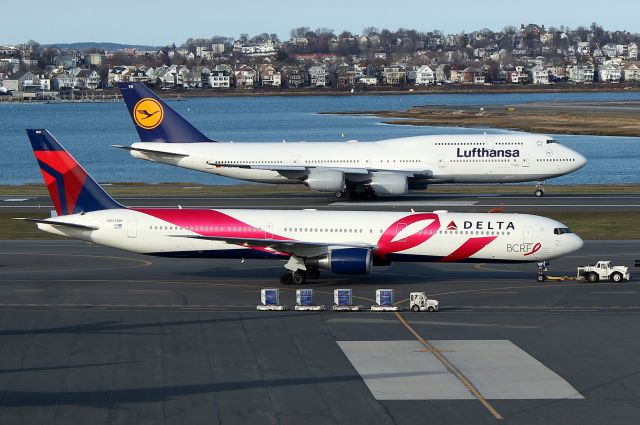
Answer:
[0,92,640,185]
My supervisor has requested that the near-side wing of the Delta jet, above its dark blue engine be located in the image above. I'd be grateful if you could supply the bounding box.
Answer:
[175,235,377,257]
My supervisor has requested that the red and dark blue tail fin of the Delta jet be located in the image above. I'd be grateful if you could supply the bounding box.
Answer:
[27,129,124,215]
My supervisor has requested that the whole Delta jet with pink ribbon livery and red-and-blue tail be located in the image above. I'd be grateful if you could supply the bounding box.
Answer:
[20,130,582,284]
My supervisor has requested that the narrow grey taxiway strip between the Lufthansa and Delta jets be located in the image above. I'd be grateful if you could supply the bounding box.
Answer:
[0,192,640,214]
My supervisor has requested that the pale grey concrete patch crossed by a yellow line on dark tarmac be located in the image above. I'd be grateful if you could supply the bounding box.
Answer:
[338,340,583,400]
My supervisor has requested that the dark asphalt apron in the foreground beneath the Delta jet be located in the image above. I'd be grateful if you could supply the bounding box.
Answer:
[0,241,640,425]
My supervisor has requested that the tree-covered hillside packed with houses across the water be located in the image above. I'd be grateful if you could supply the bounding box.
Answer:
[0,24,640,97]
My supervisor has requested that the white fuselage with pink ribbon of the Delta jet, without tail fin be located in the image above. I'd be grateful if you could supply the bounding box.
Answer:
[38,209,582,262]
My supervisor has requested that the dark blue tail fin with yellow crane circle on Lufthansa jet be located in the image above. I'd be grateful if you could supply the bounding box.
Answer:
[118,83,213,143]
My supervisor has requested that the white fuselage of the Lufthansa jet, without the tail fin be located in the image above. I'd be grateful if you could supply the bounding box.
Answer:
[131,133,586,184]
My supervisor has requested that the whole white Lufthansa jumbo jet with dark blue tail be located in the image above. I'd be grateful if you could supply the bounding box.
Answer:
[114,83,587,197]
